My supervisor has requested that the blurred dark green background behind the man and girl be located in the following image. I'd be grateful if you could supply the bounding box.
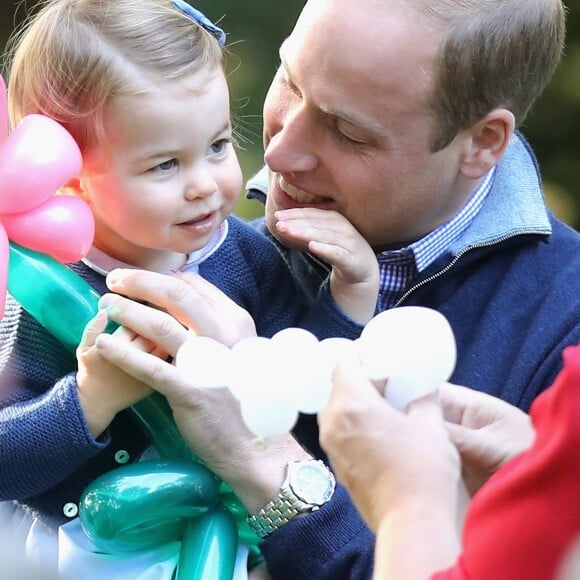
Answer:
[0,0,580,229]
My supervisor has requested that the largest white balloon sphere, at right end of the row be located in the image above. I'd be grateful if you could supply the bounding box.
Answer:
[357,306,457,411]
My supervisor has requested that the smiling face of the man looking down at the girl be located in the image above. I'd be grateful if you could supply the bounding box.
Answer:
[264,0,476,250]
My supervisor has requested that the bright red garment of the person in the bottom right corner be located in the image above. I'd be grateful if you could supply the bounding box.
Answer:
[431,345,580,580]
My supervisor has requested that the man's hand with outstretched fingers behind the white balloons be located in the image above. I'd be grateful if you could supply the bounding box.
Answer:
[96,270,309,513]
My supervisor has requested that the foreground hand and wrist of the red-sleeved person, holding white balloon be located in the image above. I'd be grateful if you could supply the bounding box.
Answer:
[318,361,461,578]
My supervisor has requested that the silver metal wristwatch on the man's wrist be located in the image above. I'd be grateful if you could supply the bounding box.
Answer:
[248,459,336,538]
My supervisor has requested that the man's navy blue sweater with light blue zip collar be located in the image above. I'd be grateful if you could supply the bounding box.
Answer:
[248,135,580,580]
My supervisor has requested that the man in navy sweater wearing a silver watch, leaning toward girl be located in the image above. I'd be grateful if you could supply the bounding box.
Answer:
[97,0,580,580]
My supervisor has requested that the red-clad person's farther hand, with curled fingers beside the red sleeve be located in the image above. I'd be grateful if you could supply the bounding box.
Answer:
[439,383,534,495]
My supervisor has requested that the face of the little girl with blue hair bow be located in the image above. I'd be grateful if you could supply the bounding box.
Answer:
[79,70,242,271]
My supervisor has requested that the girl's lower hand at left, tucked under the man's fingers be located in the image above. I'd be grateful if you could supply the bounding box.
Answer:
[76,310,157,438]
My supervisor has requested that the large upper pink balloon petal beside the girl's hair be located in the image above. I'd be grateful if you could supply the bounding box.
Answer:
[0,115,82,214]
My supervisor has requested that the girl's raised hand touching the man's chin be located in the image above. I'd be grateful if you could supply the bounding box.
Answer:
[275,208,379,324]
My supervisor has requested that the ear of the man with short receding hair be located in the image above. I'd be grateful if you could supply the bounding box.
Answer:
[461,109,515,179]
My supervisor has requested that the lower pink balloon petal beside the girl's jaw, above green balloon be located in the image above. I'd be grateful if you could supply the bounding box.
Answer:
[0,195,95,264]
